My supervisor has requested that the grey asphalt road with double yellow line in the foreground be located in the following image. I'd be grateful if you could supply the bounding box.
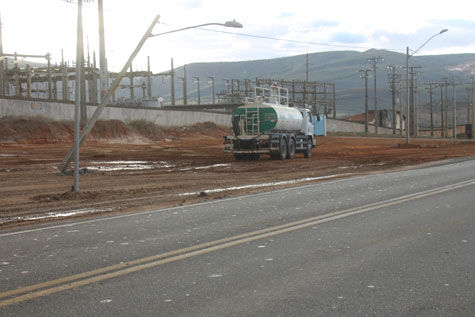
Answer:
[0,160,475,316]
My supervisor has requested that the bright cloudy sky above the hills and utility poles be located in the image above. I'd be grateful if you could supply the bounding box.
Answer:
[0,0,475,73]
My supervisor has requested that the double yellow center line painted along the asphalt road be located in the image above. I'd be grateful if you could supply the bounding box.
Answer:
[0,179,475,308]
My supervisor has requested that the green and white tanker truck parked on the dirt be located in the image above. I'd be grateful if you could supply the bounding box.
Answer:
[224,84,316,160]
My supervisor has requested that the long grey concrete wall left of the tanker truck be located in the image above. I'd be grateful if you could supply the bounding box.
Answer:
[0,99,231,126]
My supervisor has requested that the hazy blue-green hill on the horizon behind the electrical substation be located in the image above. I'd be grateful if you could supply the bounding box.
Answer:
[146,50,475,114]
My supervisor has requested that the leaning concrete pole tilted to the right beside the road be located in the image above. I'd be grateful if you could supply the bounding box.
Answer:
[59,14,160,173]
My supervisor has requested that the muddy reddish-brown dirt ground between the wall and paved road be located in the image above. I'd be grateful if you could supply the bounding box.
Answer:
[0,120,475,229]
